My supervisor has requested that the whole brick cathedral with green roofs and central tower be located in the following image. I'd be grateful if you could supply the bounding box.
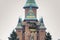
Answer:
[16,0,46,40]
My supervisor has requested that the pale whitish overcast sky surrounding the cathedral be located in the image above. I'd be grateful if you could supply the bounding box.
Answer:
[0,0,60,40]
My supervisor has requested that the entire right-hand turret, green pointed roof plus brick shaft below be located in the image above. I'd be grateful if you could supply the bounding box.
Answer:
[39,17,46,40]
